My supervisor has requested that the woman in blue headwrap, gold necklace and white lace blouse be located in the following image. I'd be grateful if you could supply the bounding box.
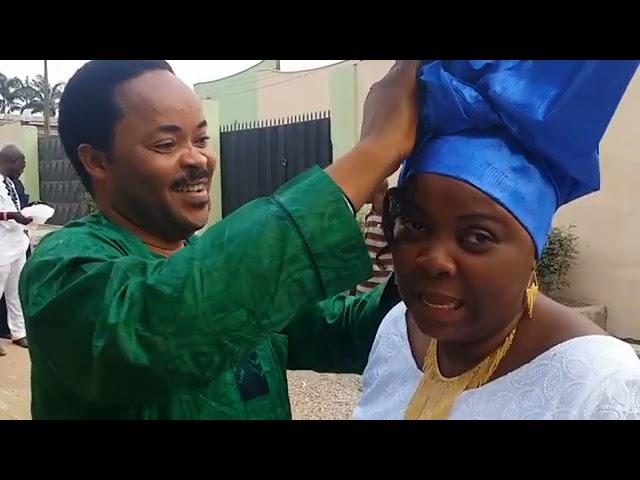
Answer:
[354,61,640,419]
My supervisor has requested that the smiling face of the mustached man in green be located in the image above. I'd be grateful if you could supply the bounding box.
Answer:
[103,70,215,241]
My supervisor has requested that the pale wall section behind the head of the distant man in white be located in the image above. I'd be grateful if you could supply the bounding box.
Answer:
[0,123,40,201]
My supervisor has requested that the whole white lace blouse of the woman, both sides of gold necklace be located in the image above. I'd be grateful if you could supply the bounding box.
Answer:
[354,303,640,420]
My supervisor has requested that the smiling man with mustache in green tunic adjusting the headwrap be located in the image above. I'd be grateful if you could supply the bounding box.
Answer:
[20,61,418,419]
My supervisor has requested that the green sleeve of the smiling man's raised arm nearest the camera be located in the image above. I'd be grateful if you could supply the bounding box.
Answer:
[20,168,371,402]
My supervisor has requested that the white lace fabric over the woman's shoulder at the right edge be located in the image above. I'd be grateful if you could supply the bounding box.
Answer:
[455,335,640,420]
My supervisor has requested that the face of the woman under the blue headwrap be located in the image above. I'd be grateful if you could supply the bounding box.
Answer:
[392,174,535,343]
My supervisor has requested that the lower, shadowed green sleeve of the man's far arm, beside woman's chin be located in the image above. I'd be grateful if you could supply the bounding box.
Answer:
[284,278,400,373]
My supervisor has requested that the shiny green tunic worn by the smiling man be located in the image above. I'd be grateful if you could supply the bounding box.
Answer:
[20,168,398,419]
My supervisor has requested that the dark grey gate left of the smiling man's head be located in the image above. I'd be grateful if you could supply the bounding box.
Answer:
[38,136,89,225]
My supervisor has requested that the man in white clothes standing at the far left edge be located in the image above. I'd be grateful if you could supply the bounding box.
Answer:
[0,145,31,355]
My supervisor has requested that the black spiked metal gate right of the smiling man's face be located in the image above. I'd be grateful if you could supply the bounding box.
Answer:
[220,112,333,216]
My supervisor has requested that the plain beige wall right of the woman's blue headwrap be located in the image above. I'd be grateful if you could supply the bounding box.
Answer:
[555,71,640,339]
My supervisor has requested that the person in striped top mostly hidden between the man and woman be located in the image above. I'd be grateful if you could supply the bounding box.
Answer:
[356,179,393,293]
